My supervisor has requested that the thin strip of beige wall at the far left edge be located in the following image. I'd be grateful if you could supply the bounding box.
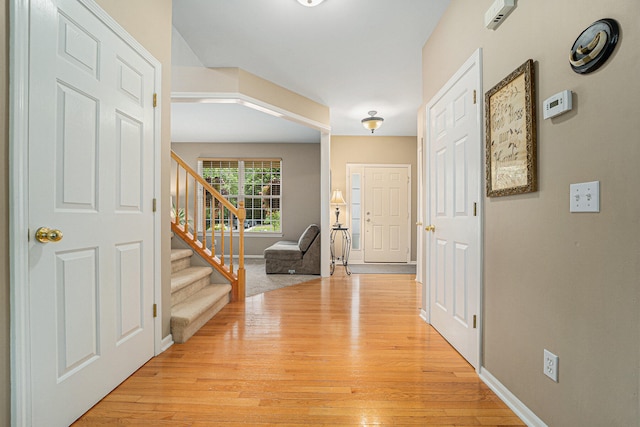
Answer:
[0,0,11,426]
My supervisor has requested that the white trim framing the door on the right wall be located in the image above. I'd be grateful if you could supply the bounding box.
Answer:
[420,48,485,373]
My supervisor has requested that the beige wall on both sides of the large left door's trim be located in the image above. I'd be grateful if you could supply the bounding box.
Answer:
[0,0,171,425]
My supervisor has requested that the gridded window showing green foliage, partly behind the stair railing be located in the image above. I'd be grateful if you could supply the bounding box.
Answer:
[198,159,282,233]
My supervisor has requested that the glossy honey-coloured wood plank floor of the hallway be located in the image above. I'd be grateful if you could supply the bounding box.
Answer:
[74,271,524,427]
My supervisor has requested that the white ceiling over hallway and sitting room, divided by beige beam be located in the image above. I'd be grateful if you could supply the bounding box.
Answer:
[171,0,449,142]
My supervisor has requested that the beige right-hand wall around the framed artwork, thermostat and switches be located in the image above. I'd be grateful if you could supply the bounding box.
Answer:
[423,0,640,427]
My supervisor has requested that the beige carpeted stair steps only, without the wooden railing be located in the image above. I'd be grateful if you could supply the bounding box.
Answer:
[171,249,231,344]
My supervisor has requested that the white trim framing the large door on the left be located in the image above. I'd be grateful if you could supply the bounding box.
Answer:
[9,0,164,426]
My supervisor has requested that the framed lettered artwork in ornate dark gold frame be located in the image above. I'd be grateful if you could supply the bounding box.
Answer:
[485,59,538,197]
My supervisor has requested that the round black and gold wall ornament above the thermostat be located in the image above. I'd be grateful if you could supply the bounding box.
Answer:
[569,18,620,74]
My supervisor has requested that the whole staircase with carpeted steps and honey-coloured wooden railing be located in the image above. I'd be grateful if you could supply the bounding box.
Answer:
[171,150,246,343]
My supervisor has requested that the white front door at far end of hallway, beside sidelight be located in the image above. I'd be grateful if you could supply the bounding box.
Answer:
[363,166,411,262]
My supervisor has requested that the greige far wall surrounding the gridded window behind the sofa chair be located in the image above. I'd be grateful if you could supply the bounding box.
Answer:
[172,143,320,256]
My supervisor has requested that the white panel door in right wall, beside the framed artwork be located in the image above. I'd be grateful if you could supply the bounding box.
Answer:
[427,52,482,367]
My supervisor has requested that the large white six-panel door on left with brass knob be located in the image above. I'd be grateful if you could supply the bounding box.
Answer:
[29,0,155,426]
